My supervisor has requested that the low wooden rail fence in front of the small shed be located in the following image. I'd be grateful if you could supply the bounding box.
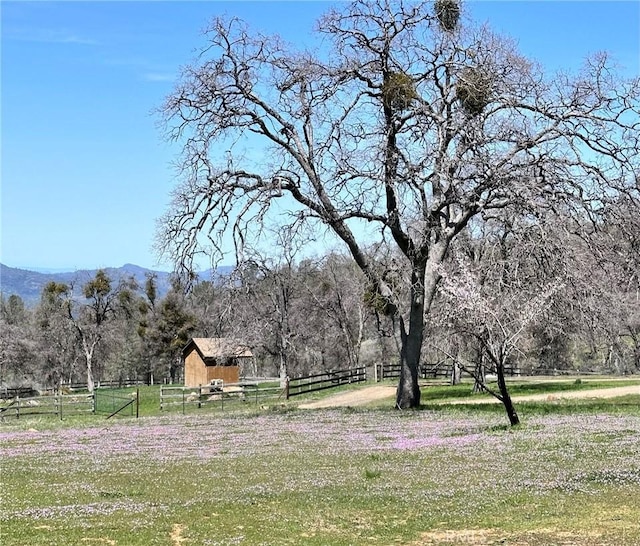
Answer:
[160,381,285,413]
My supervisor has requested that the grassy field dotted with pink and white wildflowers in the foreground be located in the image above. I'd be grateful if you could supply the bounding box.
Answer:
[0,380,640,546]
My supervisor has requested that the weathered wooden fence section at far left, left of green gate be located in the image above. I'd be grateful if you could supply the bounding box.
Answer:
[0,394,95,420]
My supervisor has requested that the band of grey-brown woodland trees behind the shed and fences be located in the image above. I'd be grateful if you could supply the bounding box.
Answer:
[0,203,640,394]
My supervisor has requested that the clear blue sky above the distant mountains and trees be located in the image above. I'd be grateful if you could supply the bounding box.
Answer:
[0,0,640,270]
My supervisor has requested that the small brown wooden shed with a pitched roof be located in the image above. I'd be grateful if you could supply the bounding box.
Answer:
[182,337,253,387]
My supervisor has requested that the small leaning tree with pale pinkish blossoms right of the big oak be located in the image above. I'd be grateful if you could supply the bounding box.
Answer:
[440,228,564,425]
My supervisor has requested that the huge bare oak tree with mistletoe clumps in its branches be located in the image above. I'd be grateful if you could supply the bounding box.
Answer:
[160,0,640,408]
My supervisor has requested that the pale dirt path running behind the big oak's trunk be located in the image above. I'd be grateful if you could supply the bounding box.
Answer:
[298,385,640,409]
